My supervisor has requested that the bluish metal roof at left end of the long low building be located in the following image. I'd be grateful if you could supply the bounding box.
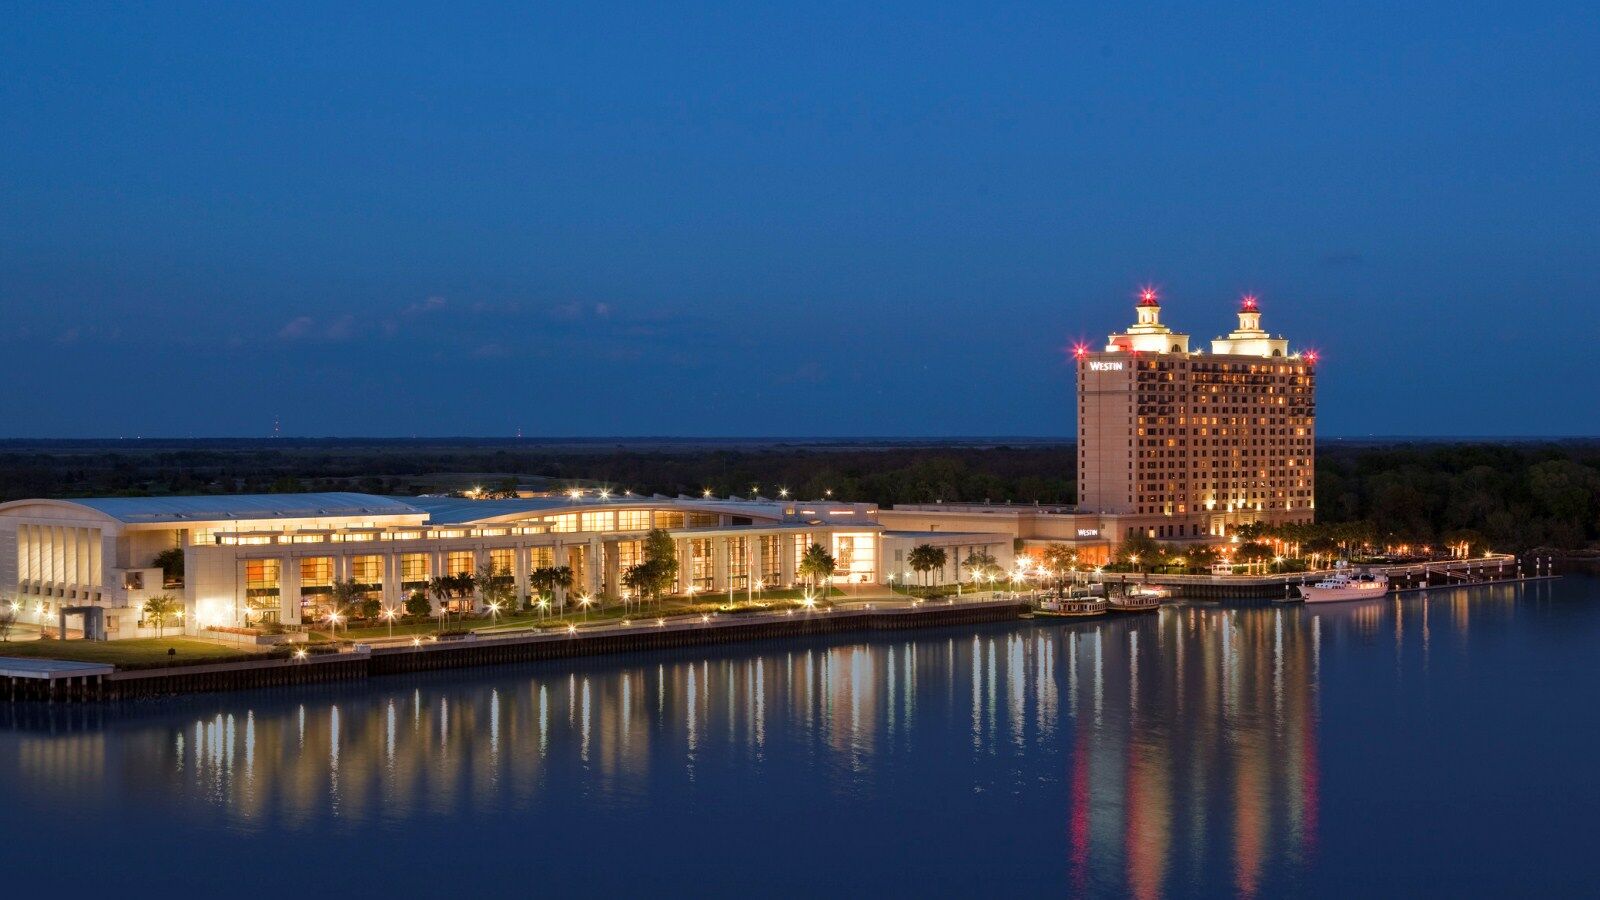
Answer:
[66,492,422,525]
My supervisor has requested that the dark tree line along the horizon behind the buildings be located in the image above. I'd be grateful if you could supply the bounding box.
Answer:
[0,440,1600,551]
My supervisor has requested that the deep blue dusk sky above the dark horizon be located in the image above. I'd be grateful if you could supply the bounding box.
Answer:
[0,2,1600,437]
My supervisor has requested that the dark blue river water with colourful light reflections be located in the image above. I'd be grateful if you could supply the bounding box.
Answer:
[0,578,1600,898]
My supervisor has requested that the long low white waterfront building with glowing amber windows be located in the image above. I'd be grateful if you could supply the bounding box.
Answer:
[0,492,1013,639]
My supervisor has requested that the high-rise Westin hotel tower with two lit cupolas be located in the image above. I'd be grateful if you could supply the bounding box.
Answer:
[1075,290,1317,540]
